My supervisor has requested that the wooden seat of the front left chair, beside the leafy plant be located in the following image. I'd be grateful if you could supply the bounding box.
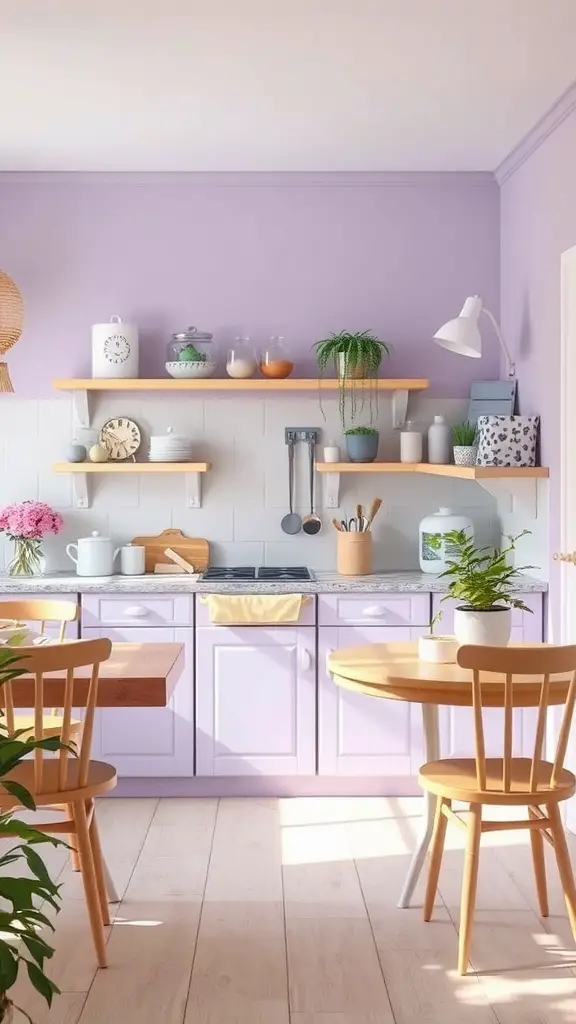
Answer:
[0,757,118,810]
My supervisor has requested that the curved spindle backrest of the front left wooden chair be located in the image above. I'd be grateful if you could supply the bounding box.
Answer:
[0,637,112,794]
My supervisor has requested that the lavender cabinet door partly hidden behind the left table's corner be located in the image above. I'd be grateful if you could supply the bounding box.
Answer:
[82,626,194,778]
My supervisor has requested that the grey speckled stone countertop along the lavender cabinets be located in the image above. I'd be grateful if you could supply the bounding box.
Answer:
[0,569,548,594]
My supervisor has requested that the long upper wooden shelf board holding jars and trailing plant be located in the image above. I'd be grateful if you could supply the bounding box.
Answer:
[54,377,429,391]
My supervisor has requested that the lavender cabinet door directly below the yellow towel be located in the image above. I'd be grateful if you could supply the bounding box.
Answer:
[196,626,316,775]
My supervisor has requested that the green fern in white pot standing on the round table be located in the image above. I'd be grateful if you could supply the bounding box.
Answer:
[440,529,535,647]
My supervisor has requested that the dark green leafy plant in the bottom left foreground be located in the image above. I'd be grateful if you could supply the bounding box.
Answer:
[0,647,63,1024]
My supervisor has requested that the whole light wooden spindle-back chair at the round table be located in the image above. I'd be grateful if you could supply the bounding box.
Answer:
[418,646,576,975]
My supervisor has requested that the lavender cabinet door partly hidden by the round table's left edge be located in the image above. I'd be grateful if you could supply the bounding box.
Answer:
[318,626,427,774]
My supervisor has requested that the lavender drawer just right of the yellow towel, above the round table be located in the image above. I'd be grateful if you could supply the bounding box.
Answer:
[318,594,430,626]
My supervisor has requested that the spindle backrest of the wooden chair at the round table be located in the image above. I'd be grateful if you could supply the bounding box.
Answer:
[457,645,576,793]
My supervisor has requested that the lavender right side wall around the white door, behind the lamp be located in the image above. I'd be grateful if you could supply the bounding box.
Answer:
[501,99,576,637]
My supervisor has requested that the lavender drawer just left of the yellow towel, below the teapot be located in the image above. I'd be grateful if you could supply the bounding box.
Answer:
[82,593,194,628]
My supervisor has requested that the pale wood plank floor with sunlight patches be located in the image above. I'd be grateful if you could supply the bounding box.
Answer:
[6,799,576,1024]
